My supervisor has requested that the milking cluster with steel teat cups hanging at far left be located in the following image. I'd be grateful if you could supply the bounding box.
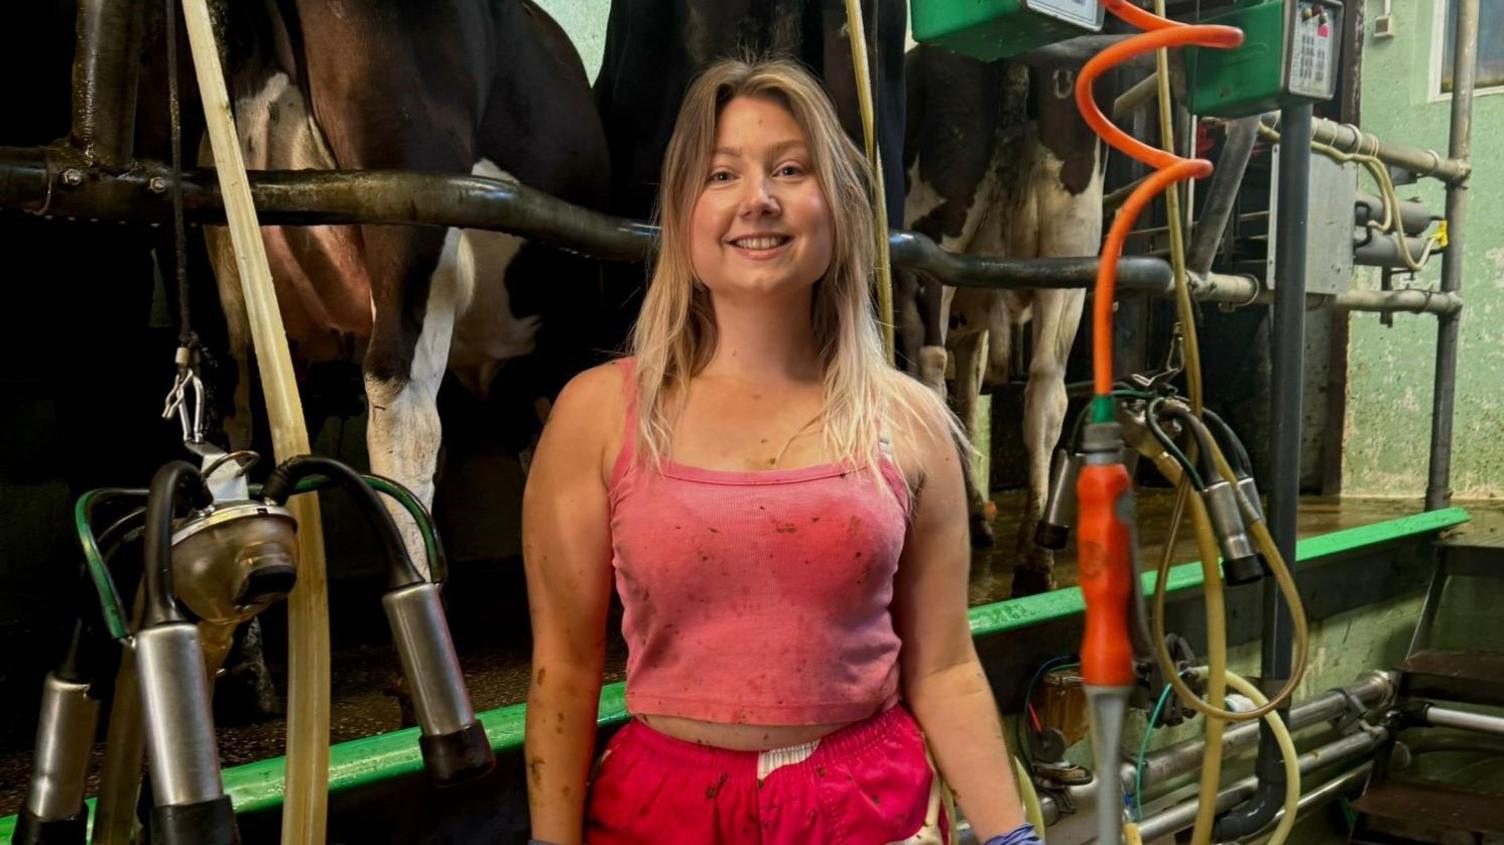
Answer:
[15,444,495,845]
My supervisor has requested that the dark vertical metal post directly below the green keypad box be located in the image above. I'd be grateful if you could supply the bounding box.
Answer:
[1212,104,1311,840]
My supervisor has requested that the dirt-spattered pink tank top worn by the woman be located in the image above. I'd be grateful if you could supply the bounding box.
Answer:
[609,359,908,725]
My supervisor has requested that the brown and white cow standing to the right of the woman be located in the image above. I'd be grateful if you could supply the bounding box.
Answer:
[896,45,1102,595]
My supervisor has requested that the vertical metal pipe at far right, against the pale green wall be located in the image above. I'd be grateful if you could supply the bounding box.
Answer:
[1426,0,1478,510]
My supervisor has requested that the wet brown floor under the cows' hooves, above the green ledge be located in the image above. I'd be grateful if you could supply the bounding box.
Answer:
[0,490,1504,815]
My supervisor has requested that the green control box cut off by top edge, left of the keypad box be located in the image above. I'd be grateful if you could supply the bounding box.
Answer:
[910,0,1104,62]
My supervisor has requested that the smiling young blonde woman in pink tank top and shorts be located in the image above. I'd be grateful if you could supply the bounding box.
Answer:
[523,62,1033,845]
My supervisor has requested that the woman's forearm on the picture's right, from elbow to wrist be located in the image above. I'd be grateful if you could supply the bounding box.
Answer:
[908,659,1024,842]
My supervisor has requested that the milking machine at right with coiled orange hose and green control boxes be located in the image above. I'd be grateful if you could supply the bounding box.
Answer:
[914,0,1340,845]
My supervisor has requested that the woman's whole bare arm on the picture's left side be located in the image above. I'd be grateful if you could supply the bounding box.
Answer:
[522,365,623,845]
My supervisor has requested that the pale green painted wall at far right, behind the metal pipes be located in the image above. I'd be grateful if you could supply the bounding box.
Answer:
[1343,0,1504,498]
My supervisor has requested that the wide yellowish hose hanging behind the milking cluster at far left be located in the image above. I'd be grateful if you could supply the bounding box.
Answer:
[183,0,329,845]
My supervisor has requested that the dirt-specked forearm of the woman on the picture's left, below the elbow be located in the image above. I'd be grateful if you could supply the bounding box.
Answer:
[523,660,600,845]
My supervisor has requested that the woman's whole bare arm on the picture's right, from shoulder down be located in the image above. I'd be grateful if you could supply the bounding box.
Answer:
[893,383,1024,842]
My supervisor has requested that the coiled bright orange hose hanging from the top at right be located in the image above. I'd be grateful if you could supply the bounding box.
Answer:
[1075,0,1242,397]
